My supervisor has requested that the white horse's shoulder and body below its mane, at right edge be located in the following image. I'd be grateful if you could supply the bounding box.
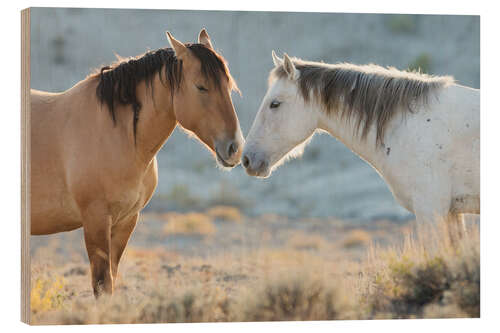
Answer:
[382,85,480,215]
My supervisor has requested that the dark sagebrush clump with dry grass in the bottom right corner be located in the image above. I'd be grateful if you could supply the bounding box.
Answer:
[364,220,480,318]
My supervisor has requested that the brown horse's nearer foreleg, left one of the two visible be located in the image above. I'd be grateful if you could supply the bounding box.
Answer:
[83,211,113,297]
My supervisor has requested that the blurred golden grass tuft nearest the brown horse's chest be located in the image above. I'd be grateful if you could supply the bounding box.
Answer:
[163,213,216,236]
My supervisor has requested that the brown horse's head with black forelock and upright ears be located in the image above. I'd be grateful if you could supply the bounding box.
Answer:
[167,29,244,167]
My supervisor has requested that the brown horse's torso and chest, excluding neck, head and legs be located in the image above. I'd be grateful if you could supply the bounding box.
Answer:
[31,78,160,235]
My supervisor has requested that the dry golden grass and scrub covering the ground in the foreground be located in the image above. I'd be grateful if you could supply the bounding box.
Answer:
[28,213,480,324]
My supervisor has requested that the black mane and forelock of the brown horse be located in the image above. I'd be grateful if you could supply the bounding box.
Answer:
[92,44,238,138]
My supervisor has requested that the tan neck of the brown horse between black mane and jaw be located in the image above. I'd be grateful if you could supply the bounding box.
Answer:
[129,74,177,164]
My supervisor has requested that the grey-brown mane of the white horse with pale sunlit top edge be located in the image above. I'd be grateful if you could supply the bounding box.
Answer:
[269,58,454,145]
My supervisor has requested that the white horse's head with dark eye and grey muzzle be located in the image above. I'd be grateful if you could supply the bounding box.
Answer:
[242,51,319,177]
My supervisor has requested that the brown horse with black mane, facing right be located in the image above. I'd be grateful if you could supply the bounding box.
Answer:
[31,29,244,297]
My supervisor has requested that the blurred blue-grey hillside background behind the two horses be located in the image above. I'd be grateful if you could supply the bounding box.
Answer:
[31,8,479,254]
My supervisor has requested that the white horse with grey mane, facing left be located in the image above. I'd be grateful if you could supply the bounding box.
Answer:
[242,51,480,234]
